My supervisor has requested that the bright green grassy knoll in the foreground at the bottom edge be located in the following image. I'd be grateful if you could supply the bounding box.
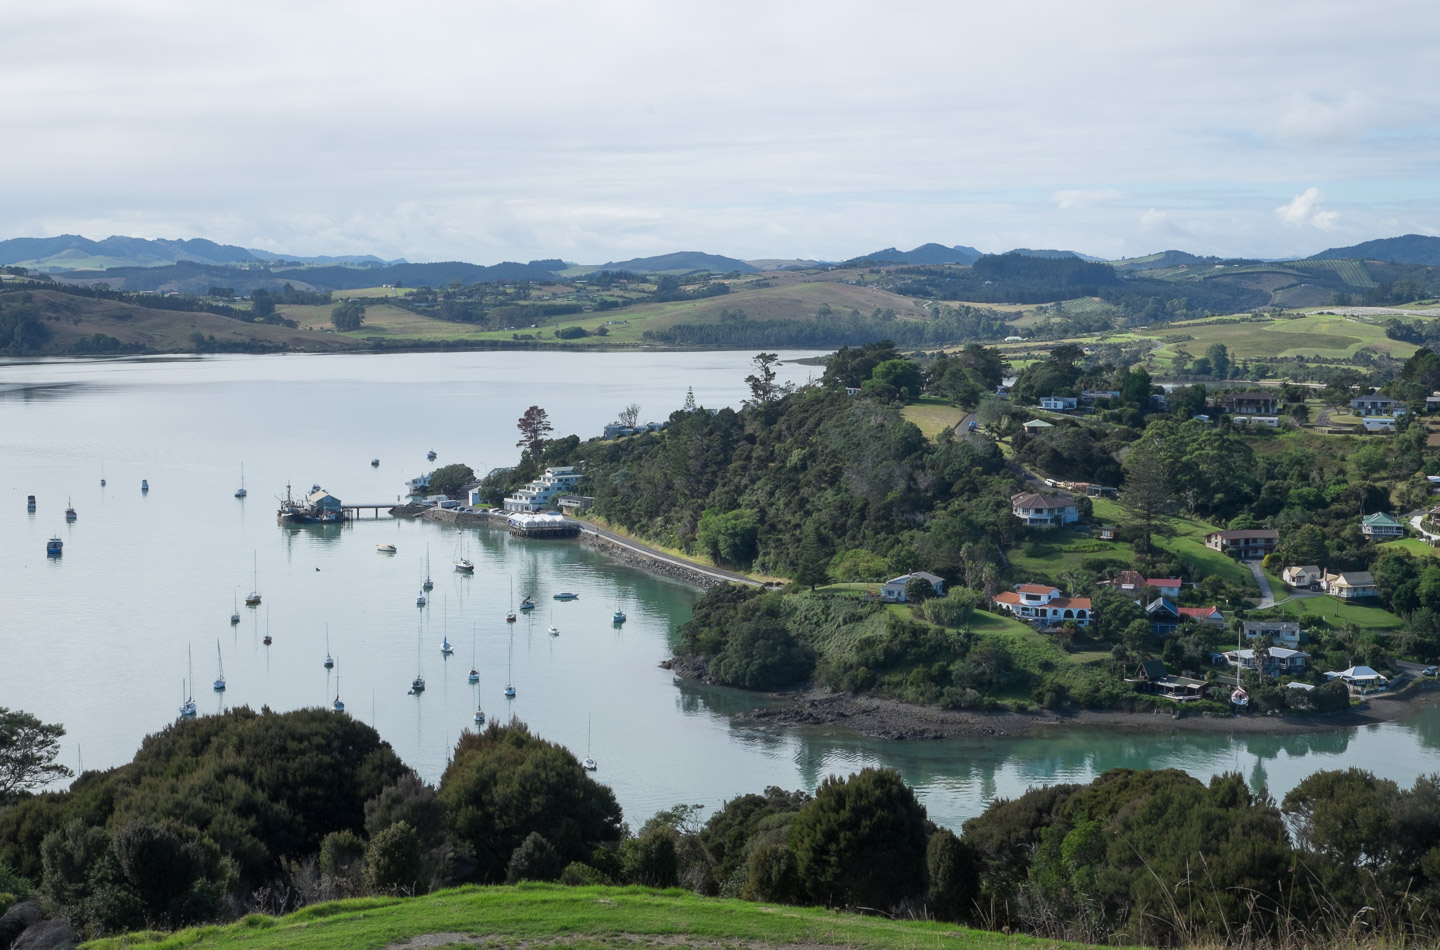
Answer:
[86,884,1100,950]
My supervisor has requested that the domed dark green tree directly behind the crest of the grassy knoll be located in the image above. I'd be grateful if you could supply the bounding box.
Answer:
[441,723,621,881]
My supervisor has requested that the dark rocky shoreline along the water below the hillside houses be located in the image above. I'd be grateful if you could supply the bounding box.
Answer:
[702,676,1440,741]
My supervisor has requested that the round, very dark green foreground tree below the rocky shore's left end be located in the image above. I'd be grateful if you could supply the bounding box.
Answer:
[789,769,926,910]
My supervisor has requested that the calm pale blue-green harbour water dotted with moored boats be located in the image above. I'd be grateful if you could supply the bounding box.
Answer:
[0,353,1440,826]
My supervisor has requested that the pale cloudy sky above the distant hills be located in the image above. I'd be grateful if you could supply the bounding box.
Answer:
[0,0,1440,263]
